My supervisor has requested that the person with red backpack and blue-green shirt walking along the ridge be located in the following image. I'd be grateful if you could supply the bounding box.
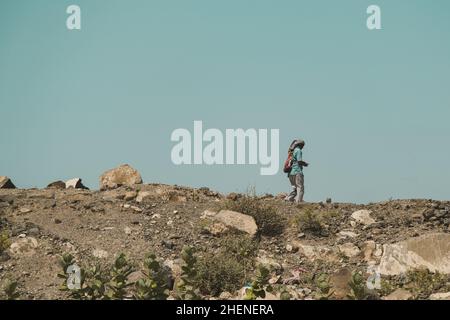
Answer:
[285,139,308,203]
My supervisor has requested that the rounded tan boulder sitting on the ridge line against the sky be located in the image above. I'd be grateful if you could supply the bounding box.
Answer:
[100,164,142,190]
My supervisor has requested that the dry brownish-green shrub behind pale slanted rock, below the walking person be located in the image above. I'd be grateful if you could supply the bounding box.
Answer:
[225,195,286,236]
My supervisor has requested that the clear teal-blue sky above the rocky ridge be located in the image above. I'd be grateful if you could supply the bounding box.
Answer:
[0,0,450,202]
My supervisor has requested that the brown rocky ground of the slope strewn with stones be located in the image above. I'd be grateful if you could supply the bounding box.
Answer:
[0,168,450,299]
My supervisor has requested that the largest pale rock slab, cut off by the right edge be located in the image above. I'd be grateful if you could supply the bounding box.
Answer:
[378,233,450,275]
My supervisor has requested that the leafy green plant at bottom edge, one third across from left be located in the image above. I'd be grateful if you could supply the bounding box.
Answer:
[134,254,169,300]
